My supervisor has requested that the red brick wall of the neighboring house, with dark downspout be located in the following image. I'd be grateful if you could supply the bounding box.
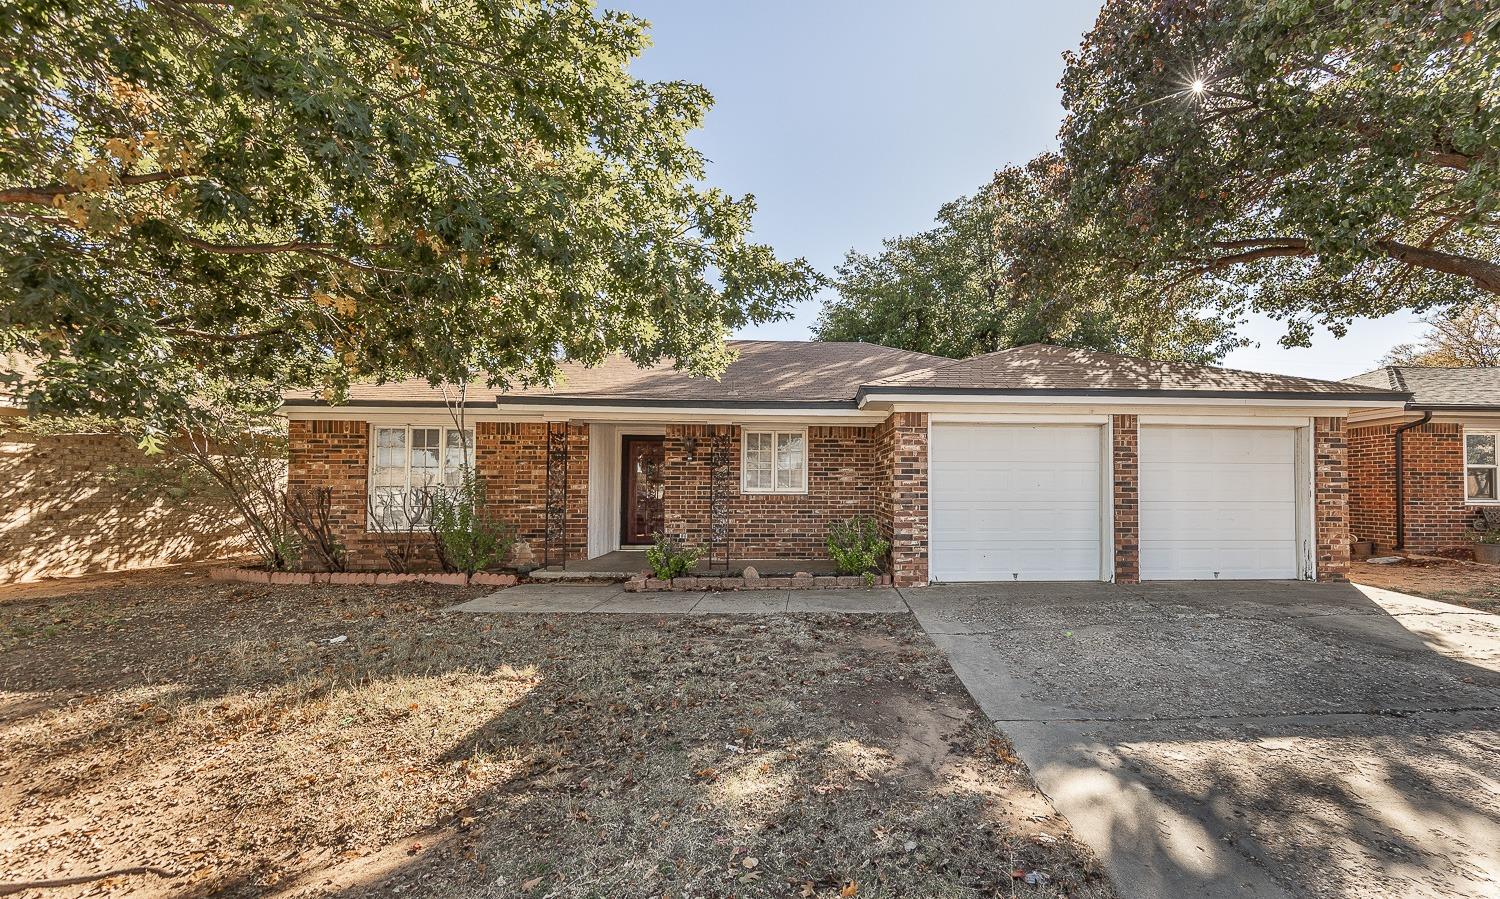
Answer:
[1349,423,1479,552]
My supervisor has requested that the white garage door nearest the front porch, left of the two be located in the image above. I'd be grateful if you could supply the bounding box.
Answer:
[929,425,1103,581]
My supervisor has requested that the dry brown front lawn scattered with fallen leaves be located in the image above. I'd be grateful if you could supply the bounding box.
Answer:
[0,572,1110,897]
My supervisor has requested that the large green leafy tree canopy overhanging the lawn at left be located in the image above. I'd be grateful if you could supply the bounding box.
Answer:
[0,0,818,422]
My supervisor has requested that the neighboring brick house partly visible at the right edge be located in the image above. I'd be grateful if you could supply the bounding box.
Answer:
[1349,366,1500,552]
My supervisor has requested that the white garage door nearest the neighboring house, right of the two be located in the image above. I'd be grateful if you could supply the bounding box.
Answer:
[1140,426,1298,581]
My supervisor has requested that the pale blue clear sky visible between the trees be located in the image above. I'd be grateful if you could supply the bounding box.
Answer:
[627,0,1421,378]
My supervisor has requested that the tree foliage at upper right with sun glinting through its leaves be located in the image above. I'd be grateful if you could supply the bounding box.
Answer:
[1061,0,1500,344]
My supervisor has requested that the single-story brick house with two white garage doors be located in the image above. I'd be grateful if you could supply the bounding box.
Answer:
[284,341,1406,585]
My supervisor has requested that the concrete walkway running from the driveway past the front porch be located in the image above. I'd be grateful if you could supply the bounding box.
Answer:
[449,584,909,615]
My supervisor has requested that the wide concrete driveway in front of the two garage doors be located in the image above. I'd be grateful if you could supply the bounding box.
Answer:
[903,582,1500,899]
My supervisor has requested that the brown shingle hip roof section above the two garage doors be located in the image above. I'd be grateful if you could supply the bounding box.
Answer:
[866,344,1394,398]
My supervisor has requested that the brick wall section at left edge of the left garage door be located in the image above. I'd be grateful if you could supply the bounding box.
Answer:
[875,413,929,587]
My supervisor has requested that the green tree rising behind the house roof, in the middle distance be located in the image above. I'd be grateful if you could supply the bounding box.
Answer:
[816,156,1239,362]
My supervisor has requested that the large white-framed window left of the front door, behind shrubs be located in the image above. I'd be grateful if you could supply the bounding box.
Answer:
[371,426,474,528]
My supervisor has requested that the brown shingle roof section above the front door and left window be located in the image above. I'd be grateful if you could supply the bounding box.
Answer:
[287,341,951,405]
